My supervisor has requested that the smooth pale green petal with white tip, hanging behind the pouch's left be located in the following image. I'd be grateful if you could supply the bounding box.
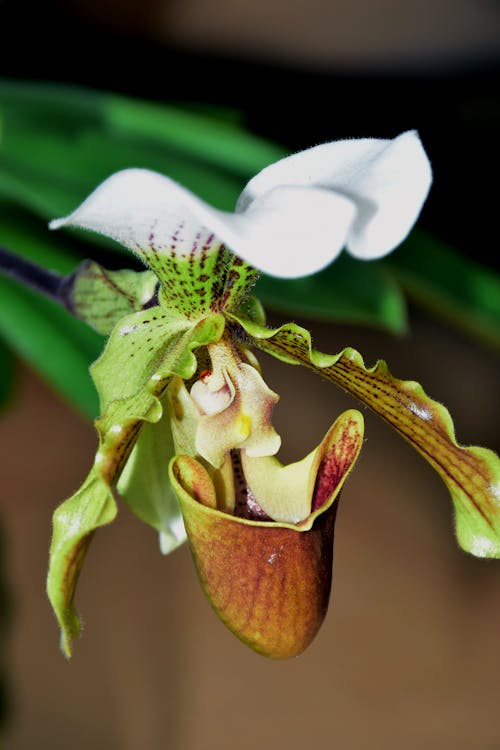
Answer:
[117,411,186,554]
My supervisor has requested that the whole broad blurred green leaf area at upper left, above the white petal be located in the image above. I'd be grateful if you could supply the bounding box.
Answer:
[0,82,284,226]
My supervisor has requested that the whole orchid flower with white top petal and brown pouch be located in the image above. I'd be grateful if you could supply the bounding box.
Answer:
[48,132,500,657]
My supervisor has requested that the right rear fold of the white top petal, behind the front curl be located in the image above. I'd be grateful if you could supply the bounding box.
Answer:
[237,131,432,264]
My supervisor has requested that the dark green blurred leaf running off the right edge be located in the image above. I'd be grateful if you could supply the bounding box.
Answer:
[383,229,500,349]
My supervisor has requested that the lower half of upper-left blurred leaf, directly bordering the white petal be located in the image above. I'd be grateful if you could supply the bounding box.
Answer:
[0,125,242,219]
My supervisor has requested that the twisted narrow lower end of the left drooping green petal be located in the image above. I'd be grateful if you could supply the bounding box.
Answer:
[47,469,116,657]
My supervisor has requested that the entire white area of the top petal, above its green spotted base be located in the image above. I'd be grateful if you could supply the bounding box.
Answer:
[50,131,431,278]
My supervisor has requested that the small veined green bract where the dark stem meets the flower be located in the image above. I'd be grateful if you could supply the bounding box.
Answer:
[68,260,158,335]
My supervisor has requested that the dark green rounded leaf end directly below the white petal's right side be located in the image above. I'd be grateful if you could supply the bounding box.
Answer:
[256,253,406,333]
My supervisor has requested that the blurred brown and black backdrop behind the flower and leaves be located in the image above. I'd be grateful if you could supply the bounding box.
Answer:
[0,0,500,750]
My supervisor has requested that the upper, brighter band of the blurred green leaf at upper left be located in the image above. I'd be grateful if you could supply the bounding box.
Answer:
[0,80,286,184]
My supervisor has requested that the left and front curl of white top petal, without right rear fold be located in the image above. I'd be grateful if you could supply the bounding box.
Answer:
[50,169,355,277]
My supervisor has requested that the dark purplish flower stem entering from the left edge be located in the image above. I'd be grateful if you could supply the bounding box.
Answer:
[0,247,73,309]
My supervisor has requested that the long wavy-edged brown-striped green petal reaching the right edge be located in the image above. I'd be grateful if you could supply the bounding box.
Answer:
[233,319,500,557]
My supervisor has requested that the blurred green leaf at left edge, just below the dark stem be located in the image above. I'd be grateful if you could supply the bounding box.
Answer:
[0,276,103,417]
